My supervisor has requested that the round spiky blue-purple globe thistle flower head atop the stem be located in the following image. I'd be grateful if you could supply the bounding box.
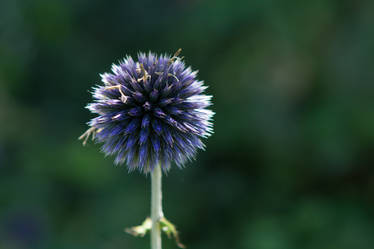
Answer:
[80,50,214,173]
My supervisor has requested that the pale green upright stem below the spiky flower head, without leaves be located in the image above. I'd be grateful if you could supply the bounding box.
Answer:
[151,165,164,249]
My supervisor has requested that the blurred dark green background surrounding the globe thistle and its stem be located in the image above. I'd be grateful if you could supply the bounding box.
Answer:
[0,0,374,249]
